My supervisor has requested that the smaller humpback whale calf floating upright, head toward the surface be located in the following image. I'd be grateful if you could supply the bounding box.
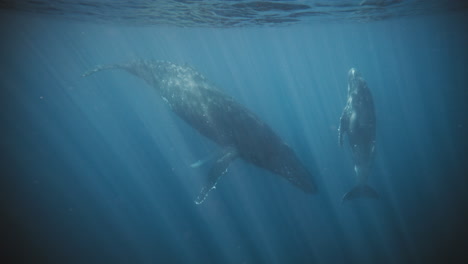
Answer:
[338,68,379,202]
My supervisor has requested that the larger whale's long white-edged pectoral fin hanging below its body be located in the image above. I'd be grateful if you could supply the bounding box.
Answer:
[195,148,238,204]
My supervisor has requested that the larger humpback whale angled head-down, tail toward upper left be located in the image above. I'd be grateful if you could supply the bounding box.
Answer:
[83,60,316,204]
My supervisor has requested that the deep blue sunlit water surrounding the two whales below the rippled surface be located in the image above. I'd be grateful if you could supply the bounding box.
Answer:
[0,2,468,263]
